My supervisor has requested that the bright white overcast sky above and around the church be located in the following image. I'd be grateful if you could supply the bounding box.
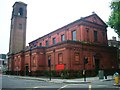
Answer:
[0,0,117,54]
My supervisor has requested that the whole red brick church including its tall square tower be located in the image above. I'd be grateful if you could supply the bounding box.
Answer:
[8,2,118,75]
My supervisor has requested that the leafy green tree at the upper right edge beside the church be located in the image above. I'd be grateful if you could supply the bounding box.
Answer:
[107,0,120,36]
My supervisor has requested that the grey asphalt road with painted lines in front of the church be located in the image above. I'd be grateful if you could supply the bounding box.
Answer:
[2,76,120,90]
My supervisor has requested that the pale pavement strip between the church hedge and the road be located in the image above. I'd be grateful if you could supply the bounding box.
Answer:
[5,75,113,84]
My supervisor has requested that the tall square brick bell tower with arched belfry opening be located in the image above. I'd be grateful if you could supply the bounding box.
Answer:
[9,2,27,54]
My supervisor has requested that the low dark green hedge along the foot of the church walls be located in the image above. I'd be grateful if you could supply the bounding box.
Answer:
[5,69,120,79]
